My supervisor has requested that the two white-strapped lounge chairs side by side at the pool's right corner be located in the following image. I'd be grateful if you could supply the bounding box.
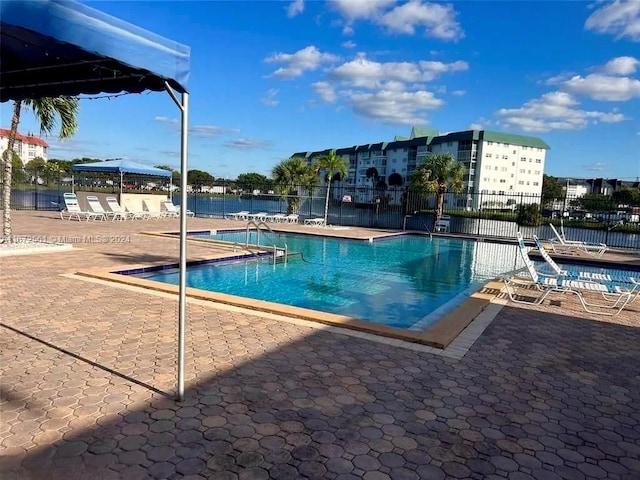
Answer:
[502,232,640,315]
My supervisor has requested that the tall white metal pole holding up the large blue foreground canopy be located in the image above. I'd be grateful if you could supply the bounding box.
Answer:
[165,82,189,402]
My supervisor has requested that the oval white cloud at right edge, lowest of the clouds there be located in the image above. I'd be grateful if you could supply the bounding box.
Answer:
[562,73,640,102]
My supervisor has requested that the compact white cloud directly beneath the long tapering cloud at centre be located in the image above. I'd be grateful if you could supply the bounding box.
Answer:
[348,90,444,125]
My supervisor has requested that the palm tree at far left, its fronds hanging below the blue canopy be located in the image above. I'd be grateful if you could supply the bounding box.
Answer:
[2,96,80,243]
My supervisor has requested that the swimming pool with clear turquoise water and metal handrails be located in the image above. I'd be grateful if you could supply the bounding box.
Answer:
[138,231,520,330]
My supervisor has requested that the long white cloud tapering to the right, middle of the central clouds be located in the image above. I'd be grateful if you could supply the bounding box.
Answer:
[331,54,469,88]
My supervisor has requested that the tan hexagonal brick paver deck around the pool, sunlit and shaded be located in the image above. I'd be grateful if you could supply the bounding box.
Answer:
[0,212,640,480]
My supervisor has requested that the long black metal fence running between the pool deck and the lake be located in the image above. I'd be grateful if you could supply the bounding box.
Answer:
[5,176,640,249]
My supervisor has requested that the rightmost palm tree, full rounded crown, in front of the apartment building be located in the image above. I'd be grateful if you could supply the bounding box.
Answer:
[411,153,464,229]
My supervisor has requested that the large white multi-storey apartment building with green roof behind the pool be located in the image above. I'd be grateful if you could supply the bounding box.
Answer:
[293,127,550,209]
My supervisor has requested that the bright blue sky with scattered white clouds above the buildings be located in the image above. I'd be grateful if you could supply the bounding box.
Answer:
[0,0,640,180]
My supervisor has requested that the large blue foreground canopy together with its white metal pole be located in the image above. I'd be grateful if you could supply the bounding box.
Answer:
[0,0,190,400]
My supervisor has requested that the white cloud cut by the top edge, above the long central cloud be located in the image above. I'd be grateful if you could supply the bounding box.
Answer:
[332,0,464,41]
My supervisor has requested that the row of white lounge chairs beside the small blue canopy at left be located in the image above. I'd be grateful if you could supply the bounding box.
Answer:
[60,193,194,221]
